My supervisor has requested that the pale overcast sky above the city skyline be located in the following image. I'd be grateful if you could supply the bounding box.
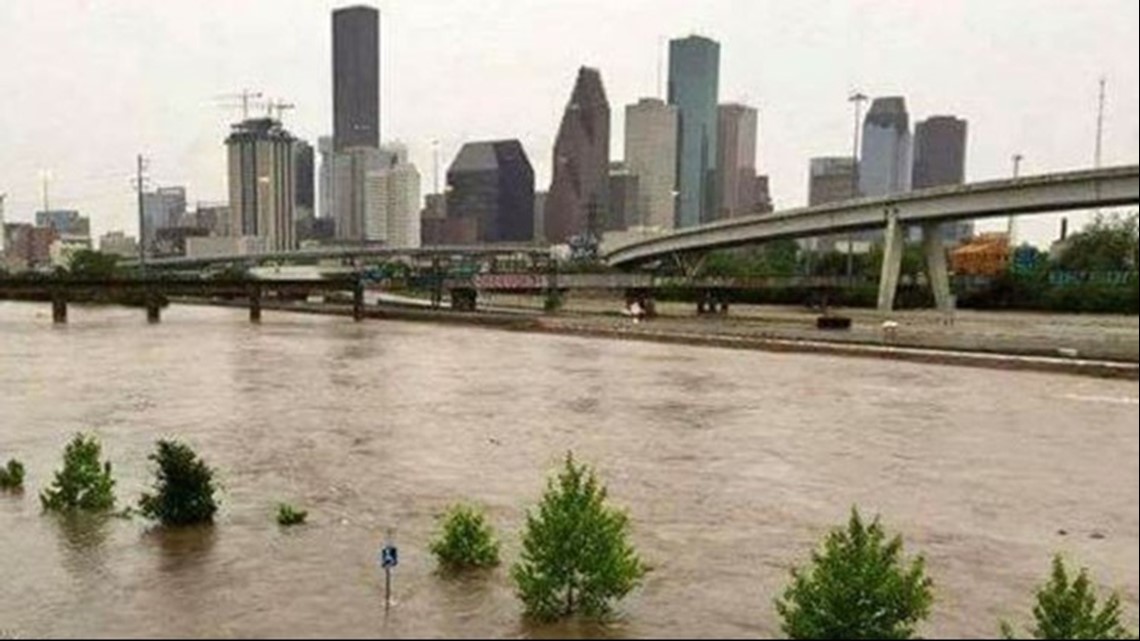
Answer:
[0,0,1140,242]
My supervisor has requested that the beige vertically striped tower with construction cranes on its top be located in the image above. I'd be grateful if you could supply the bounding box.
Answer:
[226,119,296,251]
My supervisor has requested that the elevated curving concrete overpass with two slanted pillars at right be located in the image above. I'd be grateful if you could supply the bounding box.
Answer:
[603,165,1140,313]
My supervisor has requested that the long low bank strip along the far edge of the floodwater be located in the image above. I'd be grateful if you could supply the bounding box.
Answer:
[177,299,1140,381]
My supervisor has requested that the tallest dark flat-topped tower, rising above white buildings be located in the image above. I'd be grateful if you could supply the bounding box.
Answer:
[333,6,380,152]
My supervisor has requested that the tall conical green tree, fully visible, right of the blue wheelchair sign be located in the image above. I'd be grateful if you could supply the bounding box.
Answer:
[511,454,645,622]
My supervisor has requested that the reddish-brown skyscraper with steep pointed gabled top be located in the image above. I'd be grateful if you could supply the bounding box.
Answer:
[544,67,610,244]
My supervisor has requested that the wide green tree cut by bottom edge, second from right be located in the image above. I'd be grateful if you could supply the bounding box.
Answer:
[776,510,934,640]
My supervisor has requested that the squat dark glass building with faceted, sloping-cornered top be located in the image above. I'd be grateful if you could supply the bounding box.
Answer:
[442,140,535,245]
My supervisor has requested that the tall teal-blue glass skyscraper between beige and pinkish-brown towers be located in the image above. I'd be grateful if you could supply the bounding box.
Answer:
[669,35,720,228]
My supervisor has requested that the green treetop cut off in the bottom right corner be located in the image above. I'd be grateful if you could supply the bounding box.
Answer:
[1002,557,1137,641]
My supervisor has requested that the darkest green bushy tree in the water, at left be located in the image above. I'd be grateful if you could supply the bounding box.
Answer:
[139,440,218,527]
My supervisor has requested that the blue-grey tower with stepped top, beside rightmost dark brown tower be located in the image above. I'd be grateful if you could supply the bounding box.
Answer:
[858,97,911,197]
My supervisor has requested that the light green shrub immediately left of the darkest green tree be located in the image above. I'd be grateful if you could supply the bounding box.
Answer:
[40,435,115,512]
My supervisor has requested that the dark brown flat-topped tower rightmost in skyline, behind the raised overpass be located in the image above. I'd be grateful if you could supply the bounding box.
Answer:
[913,116,974,244]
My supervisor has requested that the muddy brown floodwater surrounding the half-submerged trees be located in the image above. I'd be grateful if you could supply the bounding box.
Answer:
[0,303,1140,638]
